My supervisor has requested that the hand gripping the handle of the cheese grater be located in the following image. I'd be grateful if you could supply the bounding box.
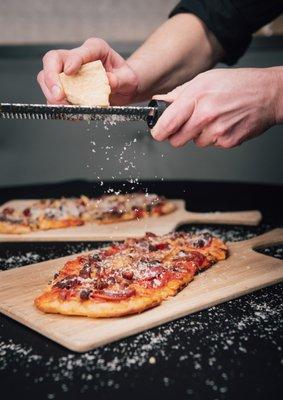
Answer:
[151,67,282,148]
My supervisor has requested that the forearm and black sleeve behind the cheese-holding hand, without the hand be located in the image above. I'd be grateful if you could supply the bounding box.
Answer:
[128,0,283,100]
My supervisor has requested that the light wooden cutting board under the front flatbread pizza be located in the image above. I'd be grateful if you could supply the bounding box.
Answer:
[0,229,283,352]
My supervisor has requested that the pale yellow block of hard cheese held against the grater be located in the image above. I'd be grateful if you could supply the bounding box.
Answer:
[59,60,111,106]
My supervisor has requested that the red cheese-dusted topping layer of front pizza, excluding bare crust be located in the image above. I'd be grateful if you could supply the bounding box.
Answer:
[47,232,229,301]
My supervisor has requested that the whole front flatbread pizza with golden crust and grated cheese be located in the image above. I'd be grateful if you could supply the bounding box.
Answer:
[35,232,228,318]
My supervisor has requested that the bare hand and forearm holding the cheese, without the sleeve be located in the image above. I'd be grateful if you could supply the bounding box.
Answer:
[38,14,222,105]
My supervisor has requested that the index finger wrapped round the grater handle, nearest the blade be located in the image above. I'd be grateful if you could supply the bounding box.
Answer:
[151,96,194,141]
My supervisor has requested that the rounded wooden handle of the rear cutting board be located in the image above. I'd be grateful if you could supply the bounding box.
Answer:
[182,210,262,226]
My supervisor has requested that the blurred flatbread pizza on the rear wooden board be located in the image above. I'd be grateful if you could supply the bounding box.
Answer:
[0,193,176,234]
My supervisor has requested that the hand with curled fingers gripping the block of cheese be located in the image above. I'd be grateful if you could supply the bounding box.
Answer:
[37,38,138,105]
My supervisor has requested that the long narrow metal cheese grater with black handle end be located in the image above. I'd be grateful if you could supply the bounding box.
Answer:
[0,100,168,129]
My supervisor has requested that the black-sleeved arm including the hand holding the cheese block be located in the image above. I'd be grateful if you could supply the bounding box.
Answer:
[38,0,283,105]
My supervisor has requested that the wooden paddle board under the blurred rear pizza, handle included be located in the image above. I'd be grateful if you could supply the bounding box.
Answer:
[0,200,262,242]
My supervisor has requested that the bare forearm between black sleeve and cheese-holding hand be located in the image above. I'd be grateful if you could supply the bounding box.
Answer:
[128,14,223,102]
